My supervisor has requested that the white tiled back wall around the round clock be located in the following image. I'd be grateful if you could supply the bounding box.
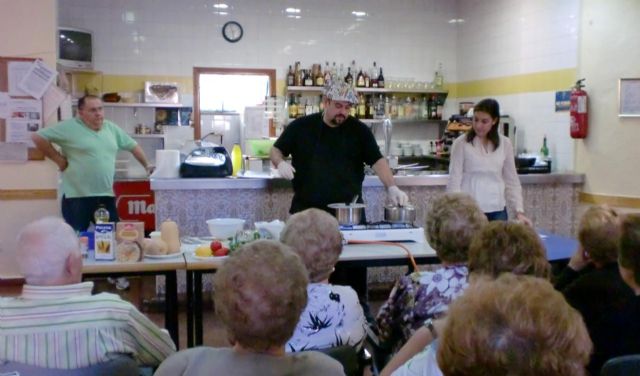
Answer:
[59,0,457,81]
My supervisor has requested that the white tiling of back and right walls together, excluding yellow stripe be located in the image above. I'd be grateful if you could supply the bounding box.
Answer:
[58,0,580,170]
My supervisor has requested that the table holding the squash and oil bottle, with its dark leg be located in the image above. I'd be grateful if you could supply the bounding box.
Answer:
[82,254,186,348]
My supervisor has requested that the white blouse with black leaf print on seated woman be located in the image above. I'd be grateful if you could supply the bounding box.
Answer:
[286,283,365,352]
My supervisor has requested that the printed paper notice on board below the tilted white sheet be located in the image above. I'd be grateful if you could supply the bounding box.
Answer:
[5,99,43,146]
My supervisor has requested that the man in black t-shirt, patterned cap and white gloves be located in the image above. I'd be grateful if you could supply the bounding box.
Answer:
[270,82,408,214]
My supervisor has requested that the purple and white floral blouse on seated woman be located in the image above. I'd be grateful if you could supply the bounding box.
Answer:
[376,265,469,346]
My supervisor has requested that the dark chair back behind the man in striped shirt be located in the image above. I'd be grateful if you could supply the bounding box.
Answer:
[0,355,140,376]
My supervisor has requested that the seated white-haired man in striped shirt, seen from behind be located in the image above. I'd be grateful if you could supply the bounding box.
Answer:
[0,217,176,370]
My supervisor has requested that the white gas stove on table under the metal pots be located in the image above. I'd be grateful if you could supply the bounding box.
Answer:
[340,222,426,243]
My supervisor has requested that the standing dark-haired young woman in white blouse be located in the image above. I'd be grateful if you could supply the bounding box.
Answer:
[447,99,532,226]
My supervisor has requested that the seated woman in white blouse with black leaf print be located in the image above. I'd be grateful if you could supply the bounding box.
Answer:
[280,209,365,352]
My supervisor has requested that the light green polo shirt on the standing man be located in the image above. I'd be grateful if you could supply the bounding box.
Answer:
[38,118,137,198]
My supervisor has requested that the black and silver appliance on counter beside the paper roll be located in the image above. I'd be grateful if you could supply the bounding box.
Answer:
[180,146,233,178]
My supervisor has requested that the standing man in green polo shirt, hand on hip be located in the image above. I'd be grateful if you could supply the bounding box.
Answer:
[31,95,154,231]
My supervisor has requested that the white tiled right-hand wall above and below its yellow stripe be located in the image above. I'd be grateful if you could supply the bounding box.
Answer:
[457,0,580,171]
